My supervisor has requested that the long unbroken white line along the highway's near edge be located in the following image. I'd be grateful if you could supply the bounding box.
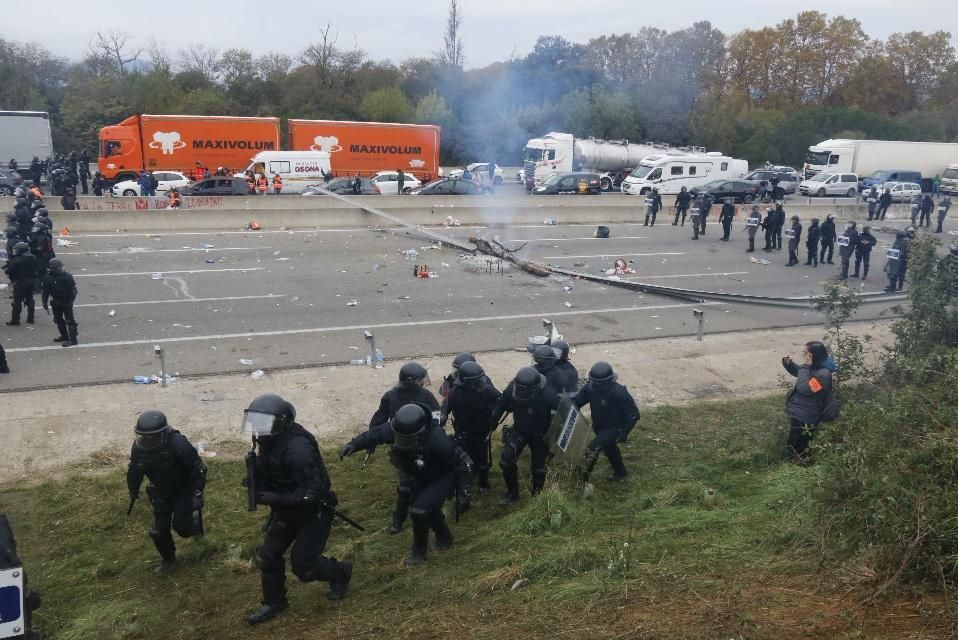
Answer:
[7,302,725,353]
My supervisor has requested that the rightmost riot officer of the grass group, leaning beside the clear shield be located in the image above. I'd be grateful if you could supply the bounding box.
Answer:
[572,362,640,482]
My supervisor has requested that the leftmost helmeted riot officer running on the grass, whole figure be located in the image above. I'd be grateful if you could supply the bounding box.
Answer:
[126,411,206,573]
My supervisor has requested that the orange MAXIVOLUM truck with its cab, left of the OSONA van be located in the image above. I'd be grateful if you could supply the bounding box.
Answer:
[98,115,284,182]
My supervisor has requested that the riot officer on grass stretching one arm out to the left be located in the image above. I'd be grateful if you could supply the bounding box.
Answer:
[340,403,472,567]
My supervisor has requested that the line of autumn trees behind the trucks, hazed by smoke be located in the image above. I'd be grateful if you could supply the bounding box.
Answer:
[0,9,958,165]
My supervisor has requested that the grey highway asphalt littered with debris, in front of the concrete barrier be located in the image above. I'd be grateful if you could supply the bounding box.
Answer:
[0,217,904,391]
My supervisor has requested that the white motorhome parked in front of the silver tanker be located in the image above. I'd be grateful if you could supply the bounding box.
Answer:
[622,151,748,195]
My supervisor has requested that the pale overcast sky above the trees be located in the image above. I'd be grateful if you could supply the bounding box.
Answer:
[0,0,958,68]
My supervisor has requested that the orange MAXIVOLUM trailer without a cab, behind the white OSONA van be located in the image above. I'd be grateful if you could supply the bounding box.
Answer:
[289,120,439,182]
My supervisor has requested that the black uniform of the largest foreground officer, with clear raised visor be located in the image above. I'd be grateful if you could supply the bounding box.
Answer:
[254,422,352,607]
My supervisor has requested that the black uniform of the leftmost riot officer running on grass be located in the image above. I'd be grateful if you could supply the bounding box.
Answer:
[126,429,206,561]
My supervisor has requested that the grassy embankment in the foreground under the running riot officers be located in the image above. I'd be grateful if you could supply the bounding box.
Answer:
[0,397,948,640]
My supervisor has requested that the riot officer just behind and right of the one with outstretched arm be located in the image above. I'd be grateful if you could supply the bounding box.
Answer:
[439,361,502,495]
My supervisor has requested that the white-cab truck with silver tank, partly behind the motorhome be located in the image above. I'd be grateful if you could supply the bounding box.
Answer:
[521,131,704,191]
